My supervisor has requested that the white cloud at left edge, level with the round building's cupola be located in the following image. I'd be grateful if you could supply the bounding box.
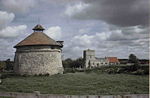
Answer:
[0,25,27,38]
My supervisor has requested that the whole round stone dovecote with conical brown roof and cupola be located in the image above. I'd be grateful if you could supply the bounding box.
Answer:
[14,24,64,75]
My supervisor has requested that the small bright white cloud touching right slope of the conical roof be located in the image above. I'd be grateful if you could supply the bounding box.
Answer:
[45,26,62,40]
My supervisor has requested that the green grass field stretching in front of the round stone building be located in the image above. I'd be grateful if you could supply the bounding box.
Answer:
[0,72,149,95]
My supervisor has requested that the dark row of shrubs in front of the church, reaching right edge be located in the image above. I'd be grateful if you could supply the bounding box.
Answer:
[85,65,149,75]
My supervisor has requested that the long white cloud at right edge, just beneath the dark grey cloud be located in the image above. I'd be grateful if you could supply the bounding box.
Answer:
[108,26,149,41]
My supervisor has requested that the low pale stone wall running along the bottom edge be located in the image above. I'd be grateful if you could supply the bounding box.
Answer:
[0,92,149,98]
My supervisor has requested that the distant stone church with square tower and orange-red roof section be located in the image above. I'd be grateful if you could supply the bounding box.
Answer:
[83,49,119,68]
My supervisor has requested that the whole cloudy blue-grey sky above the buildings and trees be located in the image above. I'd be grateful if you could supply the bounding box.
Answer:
[0,0,149,60]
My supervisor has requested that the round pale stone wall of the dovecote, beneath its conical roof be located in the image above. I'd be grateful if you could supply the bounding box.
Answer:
[14,46,63,75]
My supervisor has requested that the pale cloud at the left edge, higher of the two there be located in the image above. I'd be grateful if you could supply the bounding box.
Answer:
[0,11,15,30]
